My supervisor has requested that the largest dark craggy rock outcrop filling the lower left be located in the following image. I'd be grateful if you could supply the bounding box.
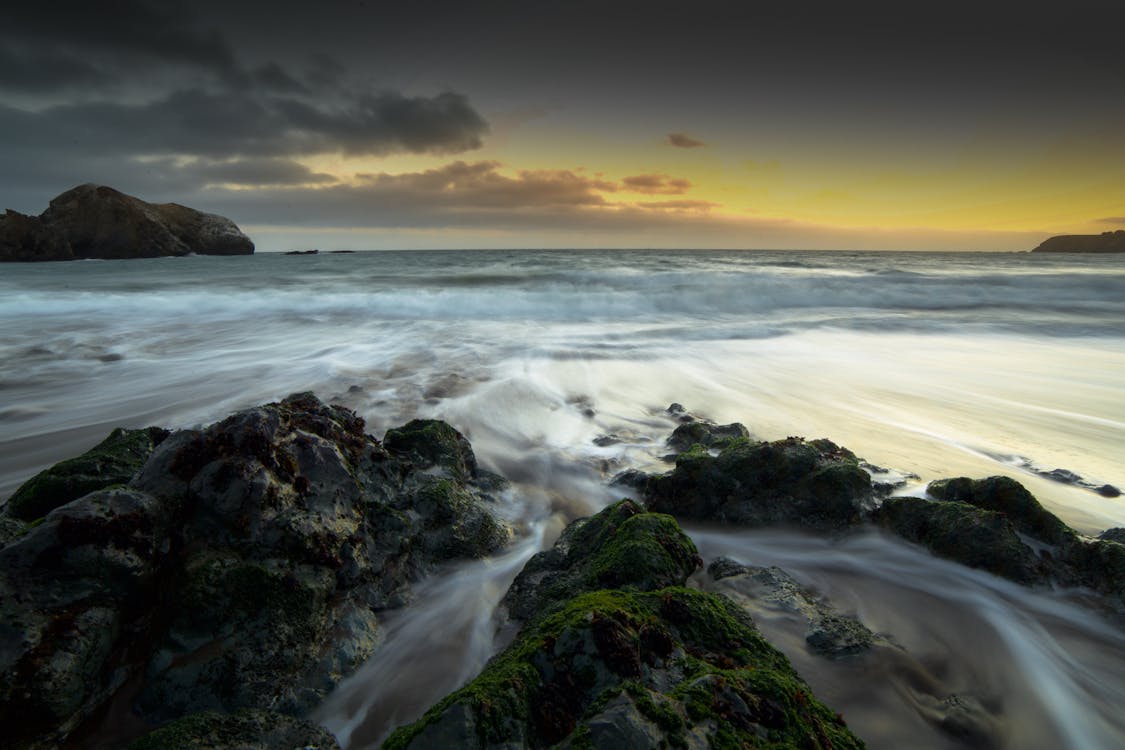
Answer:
[0,394,509,748]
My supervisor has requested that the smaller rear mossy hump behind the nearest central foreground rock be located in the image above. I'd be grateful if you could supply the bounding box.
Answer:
[504,500,702,620]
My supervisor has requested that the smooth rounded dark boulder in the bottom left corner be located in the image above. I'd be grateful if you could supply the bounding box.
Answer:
[0,488,173,748]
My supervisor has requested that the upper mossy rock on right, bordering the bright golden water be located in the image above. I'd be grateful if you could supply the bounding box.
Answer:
[926,477,1077,544]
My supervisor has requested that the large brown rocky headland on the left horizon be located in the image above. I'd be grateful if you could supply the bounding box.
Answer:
[0,184,254,262]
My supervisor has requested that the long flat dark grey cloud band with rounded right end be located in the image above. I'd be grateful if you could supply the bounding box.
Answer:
[0,89,488,165]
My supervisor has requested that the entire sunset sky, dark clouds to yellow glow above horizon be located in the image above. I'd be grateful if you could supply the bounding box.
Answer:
[0,0,1125,251]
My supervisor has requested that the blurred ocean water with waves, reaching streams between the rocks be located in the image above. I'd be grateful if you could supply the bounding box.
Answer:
[0,251,1125,748]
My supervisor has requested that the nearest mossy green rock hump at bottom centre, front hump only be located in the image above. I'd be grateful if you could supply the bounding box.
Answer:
[384,587,864,750]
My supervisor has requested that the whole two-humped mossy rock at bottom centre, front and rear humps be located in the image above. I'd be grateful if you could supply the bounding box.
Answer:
[384,500,863,750]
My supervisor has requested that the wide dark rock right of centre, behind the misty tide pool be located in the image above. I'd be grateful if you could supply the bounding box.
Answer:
[645,437,872,531]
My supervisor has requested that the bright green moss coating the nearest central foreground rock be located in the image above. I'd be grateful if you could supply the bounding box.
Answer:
[384,587,862,749]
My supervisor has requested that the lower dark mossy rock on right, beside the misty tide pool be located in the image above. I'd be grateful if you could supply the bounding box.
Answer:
[873,497,1047,584]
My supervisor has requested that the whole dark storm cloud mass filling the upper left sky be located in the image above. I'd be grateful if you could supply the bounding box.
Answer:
[0,0,488,196]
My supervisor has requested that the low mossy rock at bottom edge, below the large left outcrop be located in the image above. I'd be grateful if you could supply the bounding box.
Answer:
[128,708,340,750]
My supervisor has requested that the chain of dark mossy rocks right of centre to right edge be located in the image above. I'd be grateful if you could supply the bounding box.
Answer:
[639,416,1125,611]
